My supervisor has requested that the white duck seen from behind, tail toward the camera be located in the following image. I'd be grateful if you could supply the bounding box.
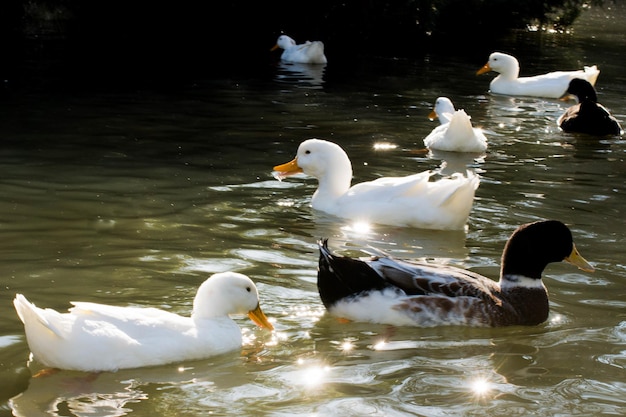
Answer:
[424,97,487,153]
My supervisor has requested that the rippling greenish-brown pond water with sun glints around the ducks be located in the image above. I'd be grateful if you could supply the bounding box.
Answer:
[0,4,626,416]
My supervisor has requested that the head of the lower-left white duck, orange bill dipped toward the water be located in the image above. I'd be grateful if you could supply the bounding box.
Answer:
[192,272,273,330]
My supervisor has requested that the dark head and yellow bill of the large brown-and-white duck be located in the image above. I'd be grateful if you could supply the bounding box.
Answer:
[500,220,594,279]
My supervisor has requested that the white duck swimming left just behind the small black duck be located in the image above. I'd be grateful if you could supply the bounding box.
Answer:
[476,52,600,98]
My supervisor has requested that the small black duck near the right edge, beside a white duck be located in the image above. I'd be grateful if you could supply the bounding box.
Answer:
[557,78,624,136]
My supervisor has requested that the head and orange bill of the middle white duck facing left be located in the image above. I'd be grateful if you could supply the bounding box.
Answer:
[274,139,352,187]
